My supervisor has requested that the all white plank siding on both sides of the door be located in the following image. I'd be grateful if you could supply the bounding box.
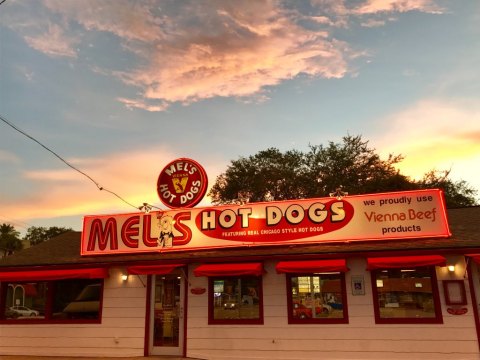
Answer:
[0,256,480,360]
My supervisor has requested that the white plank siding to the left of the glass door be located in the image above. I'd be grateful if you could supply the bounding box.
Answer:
[0,268,146,357]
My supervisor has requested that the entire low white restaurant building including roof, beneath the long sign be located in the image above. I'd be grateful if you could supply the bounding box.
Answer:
[0,198,480,360]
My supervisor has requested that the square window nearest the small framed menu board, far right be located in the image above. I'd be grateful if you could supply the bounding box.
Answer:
[372,266,442,324]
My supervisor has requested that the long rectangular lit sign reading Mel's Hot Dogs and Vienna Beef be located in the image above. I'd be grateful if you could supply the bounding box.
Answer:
[81,190,451,255]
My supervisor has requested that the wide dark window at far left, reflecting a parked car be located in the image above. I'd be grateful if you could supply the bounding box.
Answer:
[0,279,103,323]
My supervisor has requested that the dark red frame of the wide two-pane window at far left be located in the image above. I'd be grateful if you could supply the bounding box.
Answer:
[0,278,105,325]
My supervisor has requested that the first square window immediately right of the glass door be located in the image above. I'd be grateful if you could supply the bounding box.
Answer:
[208,276,263,324]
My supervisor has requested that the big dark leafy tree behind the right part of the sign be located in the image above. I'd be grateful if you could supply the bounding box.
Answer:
[208,135,477,207]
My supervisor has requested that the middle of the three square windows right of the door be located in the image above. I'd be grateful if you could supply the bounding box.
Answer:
[287,273,348,324]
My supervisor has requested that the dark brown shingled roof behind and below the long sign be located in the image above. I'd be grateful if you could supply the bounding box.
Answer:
[0,206,480,268]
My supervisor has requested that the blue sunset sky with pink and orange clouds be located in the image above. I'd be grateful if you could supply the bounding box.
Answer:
[0,0,480,233]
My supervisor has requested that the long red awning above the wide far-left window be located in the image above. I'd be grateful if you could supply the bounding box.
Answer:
[0,268,108,281]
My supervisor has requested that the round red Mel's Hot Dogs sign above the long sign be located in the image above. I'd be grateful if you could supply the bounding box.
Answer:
[157,158,208,208]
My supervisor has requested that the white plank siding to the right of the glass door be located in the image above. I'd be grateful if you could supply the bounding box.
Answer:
[187,257,480,360]
